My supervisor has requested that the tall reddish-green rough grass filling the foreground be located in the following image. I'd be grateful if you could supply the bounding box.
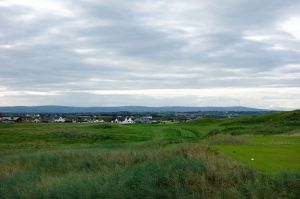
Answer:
[0,144,300,199]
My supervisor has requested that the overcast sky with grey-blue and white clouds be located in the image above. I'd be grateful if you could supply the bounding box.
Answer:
[0,0,300,109]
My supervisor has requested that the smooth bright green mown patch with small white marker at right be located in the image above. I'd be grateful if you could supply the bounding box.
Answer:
[214,136,300,172]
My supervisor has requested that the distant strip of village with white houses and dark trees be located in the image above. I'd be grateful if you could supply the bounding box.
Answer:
[0,112,251,125]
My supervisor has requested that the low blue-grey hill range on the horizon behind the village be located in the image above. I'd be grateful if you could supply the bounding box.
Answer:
[0,106,270,113]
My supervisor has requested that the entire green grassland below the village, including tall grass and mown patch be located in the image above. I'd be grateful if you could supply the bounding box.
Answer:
[0,111,300,198]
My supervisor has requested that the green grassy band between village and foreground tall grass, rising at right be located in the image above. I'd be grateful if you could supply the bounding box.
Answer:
[0,111,300,151]
